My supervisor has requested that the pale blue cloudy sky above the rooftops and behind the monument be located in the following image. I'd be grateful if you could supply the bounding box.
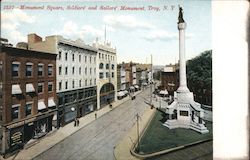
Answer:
[1,0,212,65]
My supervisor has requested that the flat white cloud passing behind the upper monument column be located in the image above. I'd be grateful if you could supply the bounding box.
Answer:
[142,30,194,41]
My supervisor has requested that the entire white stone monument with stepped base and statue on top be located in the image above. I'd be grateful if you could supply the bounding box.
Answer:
[163,7,209,133]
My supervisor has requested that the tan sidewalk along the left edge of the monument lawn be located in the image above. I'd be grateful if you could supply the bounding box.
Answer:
[114,107,156,160]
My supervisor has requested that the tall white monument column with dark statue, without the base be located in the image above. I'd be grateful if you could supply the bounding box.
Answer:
[177,7,189,92]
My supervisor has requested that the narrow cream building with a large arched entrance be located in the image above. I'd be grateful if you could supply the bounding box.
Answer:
[93,40,117,109]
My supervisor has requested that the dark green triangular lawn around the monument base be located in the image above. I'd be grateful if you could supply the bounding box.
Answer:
[136,111,213,154]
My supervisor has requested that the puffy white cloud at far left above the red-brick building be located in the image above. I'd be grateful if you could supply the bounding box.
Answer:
[1,9,36,44]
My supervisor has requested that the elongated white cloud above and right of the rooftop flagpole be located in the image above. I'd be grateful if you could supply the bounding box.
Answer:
[103,15,155,29]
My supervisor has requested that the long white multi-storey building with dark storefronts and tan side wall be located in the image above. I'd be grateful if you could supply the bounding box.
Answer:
[28,34,97,126]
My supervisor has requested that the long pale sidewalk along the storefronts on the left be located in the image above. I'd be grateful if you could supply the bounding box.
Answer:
[6,91,141,160]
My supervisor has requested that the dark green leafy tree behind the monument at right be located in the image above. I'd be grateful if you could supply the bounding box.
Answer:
[187,50,212,105]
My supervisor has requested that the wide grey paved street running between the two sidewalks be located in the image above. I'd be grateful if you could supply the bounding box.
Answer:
[34,89,149,160]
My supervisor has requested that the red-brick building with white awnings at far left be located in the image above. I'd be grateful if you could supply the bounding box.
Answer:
[0,46,57,154]
